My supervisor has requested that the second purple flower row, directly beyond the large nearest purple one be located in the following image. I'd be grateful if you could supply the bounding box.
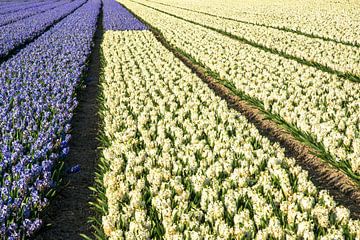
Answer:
[0,0,86,57]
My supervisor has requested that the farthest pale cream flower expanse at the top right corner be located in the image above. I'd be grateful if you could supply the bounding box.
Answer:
[146,0,360,45]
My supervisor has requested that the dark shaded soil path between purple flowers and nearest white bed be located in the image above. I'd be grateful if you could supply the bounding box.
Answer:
[34,4,102,240]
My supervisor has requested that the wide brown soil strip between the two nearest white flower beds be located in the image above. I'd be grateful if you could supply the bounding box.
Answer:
[119,1,360,219]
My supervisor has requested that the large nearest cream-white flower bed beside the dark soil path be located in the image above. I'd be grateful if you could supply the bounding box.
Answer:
[102,31,360,240]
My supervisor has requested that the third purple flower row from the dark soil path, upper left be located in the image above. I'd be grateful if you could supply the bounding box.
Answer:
[0,0,67,26]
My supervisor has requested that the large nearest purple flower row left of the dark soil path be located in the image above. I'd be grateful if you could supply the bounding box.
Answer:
[0,0,100,237]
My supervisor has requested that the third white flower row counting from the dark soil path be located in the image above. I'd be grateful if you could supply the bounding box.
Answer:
[141,0,360,77]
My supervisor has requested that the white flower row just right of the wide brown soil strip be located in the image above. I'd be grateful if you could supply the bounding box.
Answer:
[121,0,360,176]
